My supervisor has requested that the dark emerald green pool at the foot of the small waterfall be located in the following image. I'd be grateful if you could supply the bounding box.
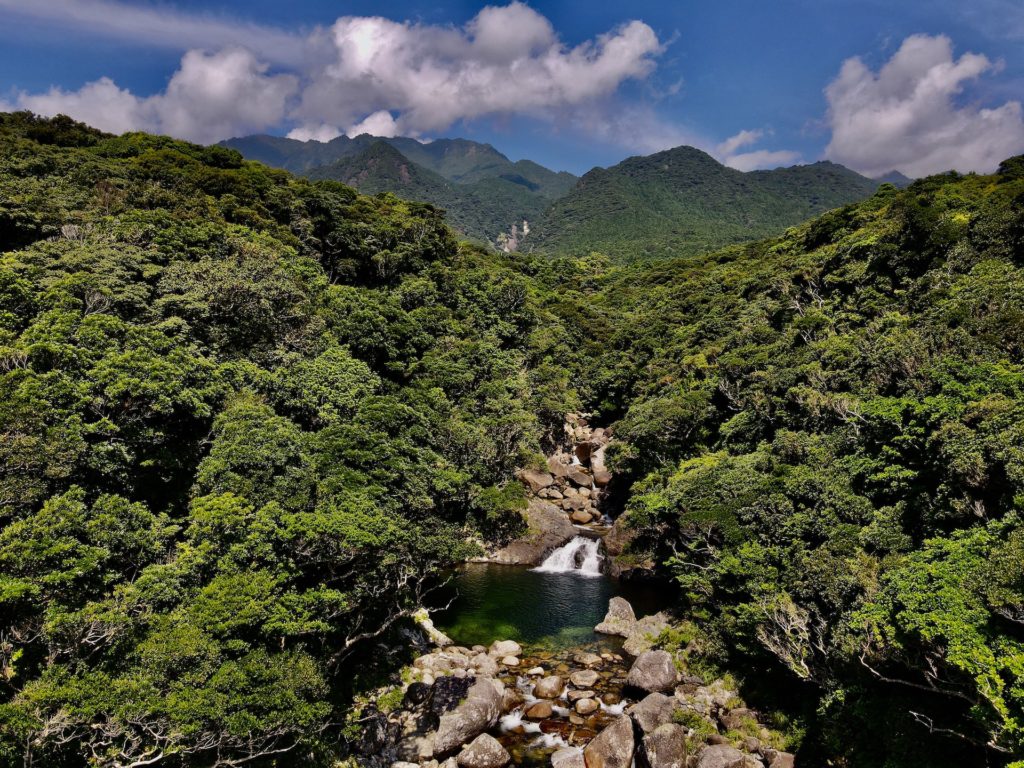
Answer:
[432,564,668,649]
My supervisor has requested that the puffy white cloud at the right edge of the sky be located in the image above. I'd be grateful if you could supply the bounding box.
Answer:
[825,35,1024,176]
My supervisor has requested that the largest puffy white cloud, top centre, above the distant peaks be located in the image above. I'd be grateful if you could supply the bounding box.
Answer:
[296,2,662,135]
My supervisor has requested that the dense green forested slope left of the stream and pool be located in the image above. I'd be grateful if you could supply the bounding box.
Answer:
[0,113,577,766]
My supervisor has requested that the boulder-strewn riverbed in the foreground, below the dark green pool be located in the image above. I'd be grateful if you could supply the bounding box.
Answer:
[356,598,794,768]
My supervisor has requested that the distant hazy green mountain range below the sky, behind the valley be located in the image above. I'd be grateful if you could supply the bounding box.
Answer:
[222,134,910,262]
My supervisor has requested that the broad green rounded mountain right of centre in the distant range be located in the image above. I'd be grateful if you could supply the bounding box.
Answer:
[524,146,878,262]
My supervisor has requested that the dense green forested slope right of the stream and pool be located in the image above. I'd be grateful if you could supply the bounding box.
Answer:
[553,158,1024,766]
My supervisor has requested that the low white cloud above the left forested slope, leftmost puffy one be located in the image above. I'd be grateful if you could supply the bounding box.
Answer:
[15,48,298,142]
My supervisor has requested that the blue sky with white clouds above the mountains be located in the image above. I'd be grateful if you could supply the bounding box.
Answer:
[0,0,1024,176]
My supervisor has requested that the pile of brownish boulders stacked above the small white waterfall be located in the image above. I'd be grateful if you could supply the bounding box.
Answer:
[519,414,611,525]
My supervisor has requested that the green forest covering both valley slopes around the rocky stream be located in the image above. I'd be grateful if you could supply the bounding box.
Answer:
[0,113,1024,768]
